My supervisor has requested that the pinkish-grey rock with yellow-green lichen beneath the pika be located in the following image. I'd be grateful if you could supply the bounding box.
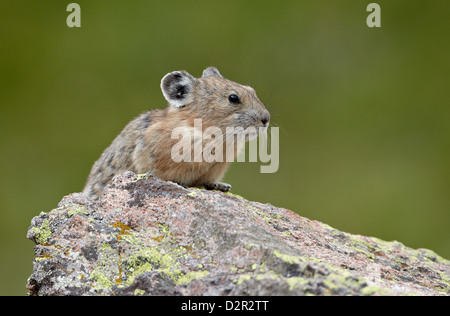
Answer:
[27,172,450,295]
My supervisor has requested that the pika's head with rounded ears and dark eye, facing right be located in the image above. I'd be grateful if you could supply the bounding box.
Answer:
[161,67,270,134]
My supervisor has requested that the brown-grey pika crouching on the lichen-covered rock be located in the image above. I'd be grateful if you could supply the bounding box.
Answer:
[83,67,270,198]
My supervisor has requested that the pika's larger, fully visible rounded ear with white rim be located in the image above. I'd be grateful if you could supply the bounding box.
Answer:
[161,71,197,107]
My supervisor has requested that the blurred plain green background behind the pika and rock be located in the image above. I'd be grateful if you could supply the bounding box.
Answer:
[0,0,450,295]
